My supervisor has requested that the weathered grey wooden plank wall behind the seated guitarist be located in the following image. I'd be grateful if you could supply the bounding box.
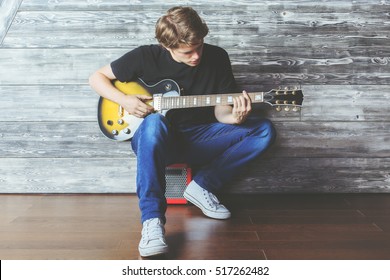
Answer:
[0,0,390,193]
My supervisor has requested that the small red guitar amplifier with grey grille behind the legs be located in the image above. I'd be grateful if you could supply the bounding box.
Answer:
[165,164,192,204]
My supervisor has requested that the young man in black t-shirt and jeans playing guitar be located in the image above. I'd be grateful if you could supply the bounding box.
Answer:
[90,7,275,257]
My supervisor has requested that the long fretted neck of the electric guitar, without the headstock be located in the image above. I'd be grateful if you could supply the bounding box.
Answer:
[157,92,264,110]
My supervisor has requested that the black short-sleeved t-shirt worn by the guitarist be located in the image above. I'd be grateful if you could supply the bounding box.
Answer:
[111,44,236,125]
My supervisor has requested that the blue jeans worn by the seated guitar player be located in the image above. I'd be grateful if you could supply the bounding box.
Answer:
[131,114,276,222]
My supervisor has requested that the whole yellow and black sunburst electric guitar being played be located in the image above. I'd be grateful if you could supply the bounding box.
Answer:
[98,79,303,141]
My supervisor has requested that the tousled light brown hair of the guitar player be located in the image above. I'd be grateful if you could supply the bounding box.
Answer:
[156,7,209,49]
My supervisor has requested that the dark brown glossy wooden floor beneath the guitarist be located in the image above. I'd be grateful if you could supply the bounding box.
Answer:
[0,194,390,260]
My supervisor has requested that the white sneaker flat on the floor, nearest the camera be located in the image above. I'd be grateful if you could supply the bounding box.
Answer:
[138,218,168,257]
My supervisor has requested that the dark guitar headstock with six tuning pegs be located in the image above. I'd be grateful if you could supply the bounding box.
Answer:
[264,87,303,112]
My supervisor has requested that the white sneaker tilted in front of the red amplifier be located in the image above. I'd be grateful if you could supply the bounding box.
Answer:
[184,181,231,219]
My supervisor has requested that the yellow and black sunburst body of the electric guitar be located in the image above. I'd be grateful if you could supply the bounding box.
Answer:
[97,79,180,141]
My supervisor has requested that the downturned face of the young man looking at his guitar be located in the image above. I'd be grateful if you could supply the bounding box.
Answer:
[167,40,203,67]
